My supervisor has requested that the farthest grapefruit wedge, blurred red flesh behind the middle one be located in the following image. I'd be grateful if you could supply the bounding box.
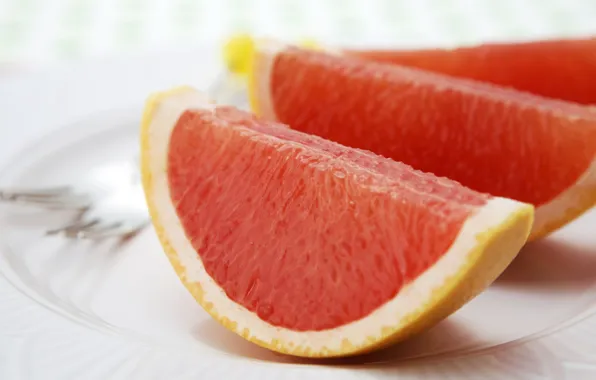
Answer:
[349,38,596,104]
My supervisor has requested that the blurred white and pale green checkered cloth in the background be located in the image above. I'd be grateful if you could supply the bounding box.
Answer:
[0,0,596,63]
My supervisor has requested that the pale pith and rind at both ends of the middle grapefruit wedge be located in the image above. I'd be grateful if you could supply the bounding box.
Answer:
[253,44,596,238]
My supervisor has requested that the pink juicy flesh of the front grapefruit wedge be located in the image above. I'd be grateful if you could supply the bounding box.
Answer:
[168,107,488,331]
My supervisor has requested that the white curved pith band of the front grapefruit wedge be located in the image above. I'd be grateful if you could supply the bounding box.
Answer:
[147,90,527,351]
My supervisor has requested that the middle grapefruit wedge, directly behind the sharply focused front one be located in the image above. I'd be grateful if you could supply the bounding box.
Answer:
[249,42,596,239]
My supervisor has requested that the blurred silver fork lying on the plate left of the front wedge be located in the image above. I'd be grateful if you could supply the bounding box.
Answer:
[0,159,149,239]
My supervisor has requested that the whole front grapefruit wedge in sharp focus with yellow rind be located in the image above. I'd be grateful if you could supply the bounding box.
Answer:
[141,88,533,357]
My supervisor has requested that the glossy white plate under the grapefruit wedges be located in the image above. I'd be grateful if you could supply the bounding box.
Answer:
[0,48,596,380]
